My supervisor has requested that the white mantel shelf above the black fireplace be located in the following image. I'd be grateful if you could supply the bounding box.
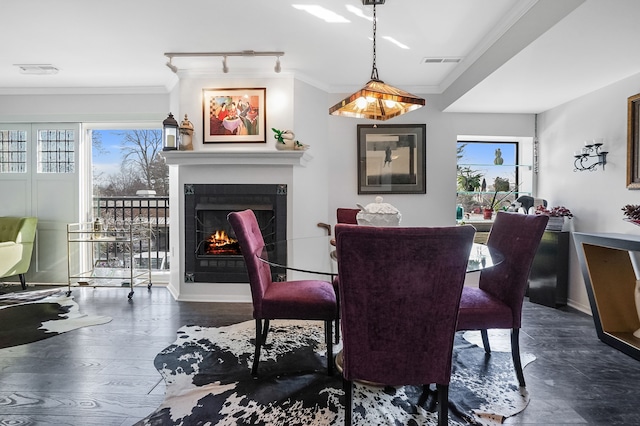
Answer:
[161,149,313,167]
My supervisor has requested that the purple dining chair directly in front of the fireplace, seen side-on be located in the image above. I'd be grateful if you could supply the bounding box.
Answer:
[228,210,338,376]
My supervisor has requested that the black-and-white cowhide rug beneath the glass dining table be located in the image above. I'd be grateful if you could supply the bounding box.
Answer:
[136,321,535,426]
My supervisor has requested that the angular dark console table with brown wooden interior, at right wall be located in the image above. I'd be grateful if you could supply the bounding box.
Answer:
[573,232,640,360]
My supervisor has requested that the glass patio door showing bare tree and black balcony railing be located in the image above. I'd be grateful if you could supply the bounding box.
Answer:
[86,123,169,282]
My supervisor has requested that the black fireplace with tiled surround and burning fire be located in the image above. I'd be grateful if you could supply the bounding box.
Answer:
[184,184,287,283]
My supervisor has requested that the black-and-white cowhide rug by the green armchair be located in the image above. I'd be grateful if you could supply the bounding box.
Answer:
[0,288,111,349]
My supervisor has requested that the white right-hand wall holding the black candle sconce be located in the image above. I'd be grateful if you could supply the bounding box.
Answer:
[538,70,640,312]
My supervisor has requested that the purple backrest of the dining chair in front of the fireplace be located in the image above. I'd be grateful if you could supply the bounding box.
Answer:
[228,210,271,318]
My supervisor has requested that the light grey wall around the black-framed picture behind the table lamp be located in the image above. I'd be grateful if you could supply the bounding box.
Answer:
[325,94,534,226]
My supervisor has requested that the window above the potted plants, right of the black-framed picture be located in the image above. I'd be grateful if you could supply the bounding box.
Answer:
[456,140,532,221]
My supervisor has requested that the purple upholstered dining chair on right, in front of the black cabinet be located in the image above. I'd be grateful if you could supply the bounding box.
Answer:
[458,212,549,387]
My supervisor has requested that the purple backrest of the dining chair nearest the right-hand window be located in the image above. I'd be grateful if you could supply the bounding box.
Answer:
[478,211,549,328]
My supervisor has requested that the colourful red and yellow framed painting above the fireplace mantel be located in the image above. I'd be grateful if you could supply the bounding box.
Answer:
[202,88,266,143]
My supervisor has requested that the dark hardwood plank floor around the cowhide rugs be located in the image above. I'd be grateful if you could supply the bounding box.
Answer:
[0,286,640,426]
